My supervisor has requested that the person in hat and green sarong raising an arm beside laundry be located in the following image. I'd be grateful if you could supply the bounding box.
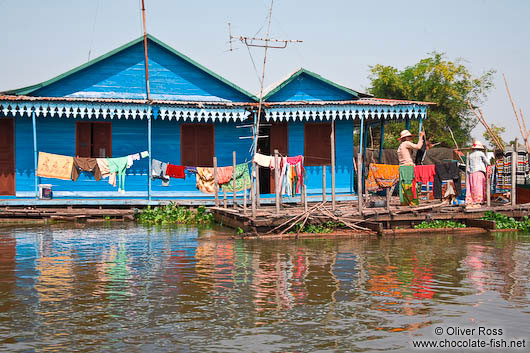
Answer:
[398,130,424,207]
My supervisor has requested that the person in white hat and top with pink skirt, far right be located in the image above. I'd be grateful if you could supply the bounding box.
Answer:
[466,140,489,208]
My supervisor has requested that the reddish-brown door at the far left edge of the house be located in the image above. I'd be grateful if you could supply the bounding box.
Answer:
[0,118,15,195]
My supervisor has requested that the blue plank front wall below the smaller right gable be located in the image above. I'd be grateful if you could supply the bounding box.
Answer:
[289,120,354,194]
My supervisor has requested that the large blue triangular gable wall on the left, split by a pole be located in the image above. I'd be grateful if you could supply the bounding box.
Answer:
[31,40,252,102]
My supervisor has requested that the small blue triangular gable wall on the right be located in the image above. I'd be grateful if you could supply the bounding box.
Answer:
[267,73,353,102]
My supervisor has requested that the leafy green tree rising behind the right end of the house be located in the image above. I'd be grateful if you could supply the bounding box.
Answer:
[369,52,495,148]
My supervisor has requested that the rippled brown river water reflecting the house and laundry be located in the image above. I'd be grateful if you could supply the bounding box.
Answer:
[0,225,530,352]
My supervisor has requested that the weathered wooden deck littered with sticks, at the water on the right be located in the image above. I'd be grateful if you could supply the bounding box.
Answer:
[210,198,530,234]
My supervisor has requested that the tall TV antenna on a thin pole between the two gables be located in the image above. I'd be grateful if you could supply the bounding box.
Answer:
[228,0,302,154]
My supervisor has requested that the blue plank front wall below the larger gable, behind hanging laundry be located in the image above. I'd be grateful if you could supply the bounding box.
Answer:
[15,117,251,198]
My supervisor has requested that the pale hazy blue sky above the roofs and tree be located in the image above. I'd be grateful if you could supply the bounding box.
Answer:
[0,0,530,144]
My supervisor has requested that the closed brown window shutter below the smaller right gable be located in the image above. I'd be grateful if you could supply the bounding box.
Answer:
[304,123,331,166]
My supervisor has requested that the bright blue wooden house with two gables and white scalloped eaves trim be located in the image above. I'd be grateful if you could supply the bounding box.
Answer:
[0,35,427,204]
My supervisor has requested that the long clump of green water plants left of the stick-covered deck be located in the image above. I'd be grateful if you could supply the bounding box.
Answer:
[135,203,213,226]
